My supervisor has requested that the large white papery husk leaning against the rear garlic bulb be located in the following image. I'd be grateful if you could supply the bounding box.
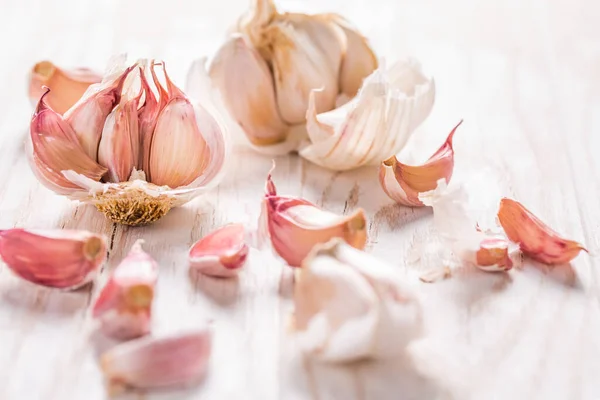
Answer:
[299,59,435,171]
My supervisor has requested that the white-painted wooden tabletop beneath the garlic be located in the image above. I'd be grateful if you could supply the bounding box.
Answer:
[0,0,600,400]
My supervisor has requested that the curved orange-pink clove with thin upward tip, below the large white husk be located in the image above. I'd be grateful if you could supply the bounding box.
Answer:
[379,121,462,207]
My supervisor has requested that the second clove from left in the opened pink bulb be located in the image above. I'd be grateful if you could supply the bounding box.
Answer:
[64,61,135,160]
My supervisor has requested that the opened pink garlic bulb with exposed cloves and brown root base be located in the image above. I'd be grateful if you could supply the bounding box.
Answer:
[29,57,227,225]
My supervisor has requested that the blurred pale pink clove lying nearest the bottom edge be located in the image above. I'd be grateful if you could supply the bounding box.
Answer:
[100,328,212,394]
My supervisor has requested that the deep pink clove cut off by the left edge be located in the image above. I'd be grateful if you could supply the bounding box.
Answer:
[0,228,106,290]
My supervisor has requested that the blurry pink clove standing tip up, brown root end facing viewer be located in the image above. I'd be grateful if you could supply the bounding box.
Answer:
[92,239,158,339]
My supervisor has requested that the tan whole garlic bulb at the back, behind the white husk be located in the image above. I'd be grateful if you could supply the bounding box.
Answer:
[210,0,381,155]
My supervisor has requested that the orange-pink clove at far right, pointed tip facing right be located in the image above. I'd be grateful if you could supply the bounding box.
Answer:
[498,198,587,264]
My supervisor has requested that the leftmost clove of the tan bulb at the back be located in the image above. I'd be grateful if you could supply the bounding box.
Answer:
[209,36,288,146]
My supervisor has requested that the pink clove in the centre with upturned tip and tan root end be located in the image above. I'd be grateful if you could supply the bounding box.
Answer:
[261,170,367,267]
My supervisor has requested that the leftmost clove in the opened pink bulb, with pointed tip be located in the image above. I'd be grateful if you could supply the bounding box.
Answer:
[30,88,106,193]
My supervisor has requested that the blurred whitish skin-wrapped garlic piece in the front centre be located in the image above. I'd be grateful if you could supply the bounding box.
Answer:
[294,239,423,362]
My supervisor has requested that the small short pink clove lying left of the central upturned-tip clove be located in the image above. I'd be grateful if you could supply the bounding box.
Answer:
[189,224,248,277]
